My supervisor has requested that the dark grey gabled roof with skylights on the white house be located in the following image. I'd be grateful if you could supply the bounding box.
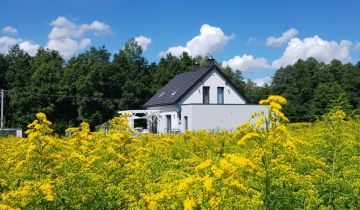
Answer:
[143,65,249,107]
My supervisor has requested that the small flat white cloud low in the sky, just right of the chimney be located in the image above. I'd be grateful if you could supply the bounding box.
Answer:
[222,54,271,72]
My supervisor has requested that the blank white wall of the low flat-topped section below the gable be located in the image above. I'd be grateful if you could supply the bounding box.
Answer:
[181,104,268,130]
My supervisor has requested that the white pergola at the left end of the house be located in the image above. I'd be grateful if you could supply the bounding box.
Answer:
[118,110,161,133]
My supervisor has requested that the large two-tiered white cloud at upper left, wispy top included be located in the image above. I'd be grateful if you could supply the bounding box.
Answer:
[46,16,111,60]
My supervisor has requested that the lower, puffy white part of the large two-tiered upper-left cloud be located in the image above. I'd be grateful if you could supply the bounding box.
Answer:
[47,38,91,60]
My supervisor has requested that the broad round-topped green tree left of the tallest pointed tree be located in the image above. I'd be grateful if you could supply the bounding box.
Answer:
[61,47,114,126]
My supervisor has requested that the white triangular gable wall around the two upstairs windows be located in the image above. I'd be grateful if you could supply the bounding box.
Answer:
[180,70,245,104]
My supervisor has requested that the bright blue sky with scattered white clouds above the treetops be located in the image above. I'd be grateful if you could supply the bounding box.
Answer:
[0,0,360,84]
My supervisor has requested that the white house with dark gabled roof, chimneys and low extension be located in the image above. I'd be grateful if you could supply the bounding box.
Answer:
[144,57,267,133]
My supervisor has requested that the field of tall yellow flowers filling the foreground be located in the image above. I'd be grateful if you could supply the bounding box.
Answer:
[0,96,360,209]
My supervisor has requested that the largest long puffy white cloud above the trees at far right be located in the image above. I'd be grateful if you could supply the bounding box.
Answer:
[272,35,352,68]
